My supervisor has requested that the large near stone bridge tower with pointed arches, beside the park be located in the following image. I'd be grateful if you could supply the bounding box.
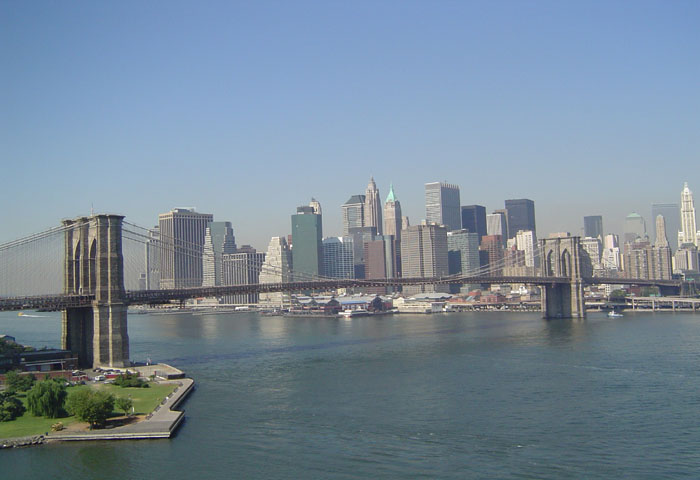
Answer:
[61,215,131,367]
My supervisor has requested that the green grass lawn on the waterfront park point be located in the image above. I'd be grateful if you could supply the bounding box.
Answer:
[0,383,177,438]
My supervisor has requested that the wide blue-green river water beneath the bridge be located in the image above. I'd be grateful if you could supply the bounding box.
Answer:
[0,312,700,480]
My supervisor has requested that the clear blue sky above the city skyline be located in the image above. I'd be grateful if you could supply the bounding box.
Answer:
[0,0,700,248]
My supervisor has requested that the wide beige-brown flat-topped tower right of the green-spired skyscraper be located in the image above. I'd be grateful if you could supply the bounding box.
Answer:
[401,222,449,295]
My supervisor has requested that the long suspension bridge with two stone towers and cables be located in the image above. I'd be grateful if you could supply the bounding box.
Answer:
[0,214,682,367]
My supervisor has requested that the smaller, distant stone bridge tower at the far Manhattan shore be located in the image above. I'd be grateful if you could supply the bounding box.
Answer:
[540,237,592,318]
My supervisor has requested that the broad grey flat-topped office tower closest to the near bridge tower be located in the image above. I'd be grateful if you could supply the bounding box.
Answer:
[158,208,214,288]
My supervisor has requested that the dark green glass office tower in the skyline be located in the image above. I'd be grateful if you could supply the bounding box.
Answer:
[292,205,323,281]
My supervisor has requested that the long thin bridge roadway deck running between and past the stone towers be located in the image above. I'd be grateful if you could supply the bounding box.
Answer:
[0,275,681,311]
